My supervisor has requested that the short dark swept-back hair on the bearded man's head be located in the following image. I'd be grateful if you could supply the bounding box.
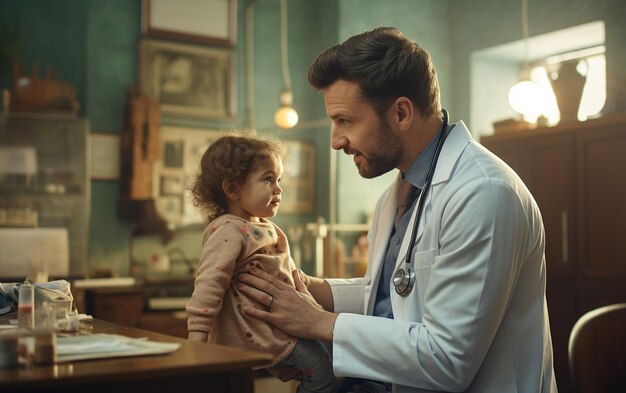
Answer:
[308,27,441,117]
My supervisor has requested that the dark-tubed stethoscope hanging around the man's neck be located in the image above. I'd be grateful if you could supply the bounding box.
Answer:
[393,109,448,297]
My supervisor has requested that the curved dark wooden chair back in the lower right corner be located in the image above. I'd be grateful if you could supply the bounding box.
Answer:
[568,303,626,393]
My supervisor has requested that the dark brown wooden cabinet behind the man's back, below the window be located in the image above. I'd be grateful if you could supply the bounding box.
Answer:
[481,114,626,392]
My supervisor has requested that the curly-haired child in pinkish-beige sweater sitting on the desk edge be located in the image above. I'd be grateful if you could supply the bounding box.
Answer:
[186,135,335,392]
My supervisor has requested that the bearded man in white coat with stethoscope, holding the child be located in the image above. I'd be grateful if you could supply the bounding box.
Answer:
[239,27,557,393]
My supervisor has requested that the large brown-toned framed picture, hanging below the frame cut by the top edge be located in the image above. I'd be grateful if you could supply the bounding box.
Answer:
[139,38,235,119]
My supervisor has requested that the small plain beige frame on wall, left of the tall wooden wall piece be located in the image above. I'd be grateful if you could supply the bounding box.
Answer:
[89,132,120,180]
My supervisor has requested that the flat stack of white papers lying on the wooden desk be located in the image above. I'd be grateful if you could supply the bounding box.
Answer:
[57,334,180,363]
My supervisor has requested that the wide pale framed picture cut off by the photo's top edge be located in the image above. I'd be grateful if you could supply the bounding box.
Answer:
[142,0,237,45]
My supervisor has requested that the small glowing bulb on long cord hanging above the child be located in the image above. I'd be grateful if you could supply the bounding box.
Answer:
[274,0,298,129]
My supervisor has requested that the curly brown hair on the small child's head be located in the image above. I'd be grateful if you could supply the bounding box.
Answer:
[190,132,284,222]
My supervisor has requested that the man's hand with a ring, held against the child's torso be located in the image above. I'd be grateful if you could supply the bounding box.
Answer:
[238,267,337,341]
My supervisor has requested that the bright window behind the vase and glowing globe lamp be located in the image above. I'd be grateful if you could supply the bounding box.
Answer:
[469,21,606,137]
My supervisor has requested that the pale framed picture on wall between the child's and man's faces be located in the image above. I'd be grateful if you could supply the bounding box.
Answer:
[278,140,315,214]
